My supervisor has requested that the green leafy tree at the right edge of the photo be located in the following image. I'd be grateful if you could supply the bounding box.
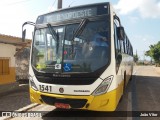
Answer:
[145,41,160,64]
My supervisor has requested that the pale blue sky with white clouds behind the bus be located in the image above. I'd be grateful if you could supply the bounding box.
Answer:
[0,0,160,60]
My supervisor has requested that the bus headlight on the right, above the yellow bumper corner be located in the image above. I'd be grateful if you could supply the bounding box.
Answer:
[92,76,113,96]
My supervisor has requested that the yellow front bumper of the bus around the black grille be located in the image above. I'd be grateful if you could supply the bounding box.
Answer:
[30,88,118,111]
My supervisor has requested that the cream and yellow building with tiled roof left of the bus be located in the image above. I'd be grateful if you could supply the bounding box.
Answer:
[0,34,31,85]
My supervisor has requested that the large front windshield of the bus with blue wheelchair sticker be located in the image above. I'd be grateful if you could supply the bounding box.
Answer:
[32,21,110,73]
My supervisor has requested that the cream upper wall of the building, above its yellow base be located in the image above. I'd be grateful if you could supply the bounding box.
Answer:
[0,43,16,67]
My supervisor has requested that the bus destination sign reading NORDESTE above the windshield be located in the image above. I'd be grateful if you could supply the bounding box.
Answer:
[36,4,109,24]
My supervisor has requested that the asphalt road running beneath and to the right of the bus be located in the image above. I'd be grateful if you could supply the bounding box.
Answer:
[1,66,160,120]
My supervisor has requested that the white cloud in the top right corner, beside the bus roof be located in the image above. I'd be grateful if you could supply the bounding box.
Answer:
[114,0,160,18]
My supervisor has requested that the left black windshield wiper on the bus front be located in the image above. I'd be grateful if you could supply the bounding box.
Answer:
[47,23,59,54]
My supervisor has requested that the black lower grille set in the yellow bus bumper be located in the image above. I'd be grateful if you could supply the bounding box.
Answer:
[41,95,87,108]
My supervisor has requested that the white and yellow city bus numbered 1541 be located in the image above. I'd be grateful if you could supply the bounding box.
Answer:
[22,2,133,111]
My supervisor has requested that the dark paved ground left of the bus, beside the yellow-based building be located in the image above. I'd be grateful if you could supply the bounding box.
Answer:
[0,85,31,111]
